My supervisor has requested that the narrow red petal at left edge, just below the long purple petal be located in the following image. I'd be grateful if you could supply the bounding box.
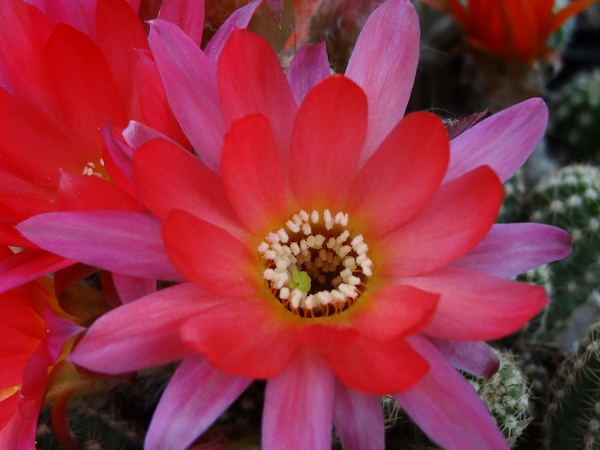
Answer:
[0,248,75,293]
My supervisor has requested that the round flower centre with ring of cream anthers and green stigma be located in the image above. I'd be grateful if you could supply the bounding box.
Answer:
[258,209,373,318]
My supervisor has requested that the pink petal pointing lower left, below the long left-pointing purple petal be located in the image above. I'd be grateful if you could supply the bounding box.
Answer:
[69,283,225,374]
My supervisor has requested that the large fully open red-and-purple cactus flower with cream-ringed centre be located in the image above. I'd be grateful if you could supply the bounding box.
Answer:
[18,0,570,450]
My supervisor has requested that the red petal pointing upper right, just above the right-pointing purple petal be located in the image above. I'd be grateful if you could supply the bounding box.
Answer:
[382,166,504,277]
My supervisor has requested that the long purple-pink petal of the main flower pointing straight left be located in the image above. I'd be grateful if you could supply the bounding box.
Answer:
[16,210,182,281]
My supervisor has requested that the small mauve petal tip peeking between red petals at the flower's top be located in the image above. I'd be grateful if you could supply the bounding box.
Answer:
[287,42,330,105]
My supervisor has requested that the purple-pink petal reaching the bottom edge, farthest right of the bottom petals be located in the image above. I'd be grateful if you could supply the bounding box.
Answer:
[394,336,509,450]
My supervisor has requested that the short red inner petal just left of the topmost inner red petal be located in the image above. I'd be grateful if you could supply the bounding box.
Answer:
[221,114,288,233]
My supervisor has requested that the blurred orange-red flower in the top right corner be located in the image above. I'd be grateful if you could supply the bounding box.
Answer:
[421,0,598,65]
